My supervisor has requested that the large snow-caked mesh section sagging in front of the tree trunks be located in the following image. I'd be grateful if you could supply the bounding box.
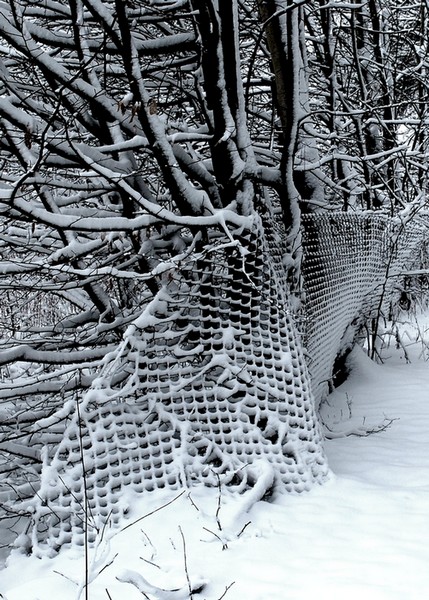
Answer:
[28,217,327,552]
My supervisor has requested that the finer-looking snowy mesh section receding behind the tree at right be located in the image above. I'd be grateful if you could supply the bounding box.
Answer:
[302,213,429,406]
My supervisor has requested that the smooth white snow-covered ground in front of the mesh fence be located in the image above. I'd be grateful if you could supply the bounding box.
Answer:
[0,314,429,600]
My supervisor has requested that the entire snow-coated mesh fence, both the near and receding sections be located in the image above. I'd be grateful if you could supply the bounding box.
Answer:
[1,209,426,555]
